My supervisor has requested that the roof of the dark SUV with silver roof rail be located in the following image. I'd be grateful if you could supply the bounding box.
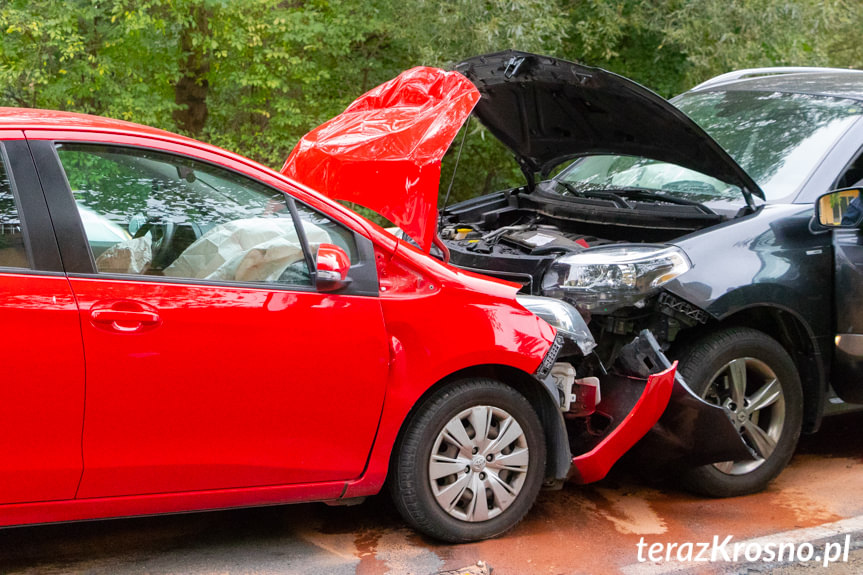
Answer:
[690,68,863,101]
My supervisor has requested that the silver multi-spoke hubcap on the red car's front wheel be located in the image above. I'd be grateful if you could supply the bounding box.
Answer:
[428,405,530,522]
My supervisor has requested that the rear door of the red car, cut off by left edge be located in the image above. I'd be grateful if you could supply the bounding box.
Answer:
[0,134,84,504]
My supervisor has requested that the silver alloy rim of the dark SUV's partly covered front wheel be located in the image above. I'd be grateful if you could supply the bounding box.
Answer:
[703,357,785,475]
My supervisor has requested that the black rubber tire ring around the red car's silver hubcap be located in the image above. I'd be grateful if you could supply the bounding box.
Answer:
[390,379,546,542]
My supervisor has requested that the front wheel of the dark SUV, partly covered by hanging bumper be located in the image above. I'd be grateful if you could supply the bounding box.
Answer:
[678,327,803,497]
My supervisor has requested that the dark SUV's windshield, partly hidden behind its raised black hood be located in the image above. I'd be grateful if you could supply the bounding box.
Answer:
[554,91,863,204]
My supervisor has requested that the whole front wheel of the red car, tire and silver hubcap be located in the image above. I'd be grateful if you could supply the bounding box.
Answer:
[389,378,546,543]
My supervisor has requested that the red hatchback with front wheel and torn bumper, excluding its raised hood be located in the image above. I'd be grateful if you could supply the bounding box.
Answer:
[0,71,739,541]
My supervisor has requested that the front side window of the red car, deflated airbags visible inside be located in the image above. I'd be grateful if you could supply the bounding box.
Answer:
[57,144,322,286]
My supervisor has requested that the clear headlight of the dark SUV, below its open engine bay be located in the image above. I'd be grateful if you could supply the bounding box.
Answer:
[542,244,692,313]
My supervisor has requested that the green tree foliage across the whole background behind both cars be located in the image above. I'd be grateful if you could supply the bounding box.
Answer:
[0,0,863,212]
